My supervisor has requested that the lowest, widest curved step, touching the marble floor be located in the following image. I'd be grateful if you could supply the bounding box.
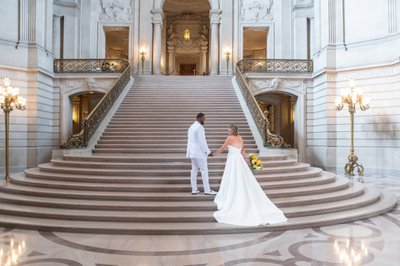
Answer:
[0,190,397,235]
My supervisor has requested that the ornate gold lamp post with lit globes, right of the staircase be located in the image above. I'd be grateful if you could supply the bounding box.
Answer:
[335,79,369,179]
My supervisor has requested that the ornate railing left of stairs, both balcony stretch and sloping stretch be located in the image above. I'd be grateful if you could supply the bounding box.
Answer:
[54,59,130,149]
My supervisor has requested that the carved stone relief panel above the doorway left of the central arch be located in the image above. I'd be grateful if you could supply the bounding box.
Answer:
[99,0,133,22]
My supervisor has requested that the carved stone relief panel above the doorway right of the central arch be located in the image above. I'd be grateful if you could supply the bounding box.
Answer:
[239,0,274,22]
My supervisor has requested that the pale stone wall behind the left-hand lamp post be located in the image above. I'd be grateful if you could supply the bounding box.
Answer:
[0,0,59,172]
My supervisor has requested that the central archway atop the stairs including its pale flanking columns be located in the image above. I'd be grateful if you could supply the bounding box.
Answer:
[152,0,221,75]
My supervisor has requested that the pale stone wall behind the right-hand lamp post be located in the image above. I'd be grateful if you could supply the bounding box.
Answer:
[307,0,400,174]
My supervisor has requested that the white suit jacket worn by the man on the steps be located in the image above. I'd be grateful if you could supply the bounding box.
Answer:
[186,121,211,159]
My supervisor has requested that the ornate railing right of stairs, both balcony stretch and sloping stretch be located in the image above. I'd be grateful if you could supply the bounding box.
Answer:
[235,59,312,148]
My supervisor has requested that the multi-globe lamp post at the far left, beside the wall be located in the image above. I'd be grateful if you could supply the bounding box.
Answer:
[0,78,26,183]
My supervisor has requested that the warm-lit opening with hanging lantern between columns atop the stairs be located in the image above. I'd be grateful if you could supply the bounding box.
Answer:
[161,0,211,75]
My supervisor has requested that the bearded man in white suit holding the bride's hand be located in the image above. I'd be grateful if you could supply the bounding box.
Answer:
[186,113,217,195]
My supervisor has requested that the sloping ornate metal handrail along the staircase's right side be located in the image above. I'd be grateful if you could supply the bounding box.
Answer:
[235,60,290,148]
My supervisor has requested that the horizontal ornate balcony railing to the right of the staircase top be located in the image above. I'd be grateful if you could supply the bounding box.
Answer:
[236,59,313,73]
